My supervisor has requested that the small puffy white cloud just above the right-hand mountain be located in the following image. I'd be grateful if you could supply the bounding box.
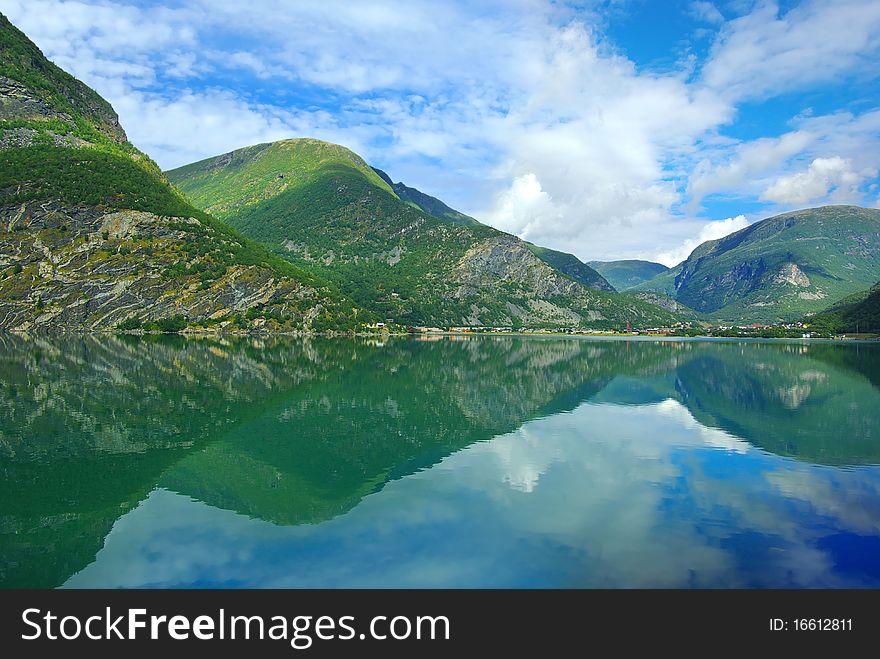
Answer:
[761,156,865,204]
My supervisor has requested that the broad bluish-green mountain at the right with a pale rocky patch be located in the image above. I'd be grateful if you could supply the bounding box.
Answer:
[633,206,880,322]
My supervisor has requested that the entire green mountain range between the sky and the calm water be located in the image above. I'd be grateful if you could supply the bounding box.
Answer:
[0,10,880,333]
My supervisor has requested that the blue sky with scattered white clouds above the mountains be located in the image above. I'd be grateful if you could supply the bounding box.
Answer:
[0,0,880,266]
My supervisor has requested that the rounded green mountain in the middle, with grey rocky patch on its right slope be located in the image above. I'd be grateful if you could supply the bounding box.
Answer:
[167,139,676,328]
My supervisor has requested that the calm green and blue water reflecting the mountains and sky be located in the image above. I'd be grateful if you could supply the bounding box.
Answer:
[0,336,880,587]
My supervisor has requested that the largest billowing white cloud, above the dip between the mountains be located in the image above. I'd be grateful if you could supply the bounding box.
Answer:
[477,25,729,258]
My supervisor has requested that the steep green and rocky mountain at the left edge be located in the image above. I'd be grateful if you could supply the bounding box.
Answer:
[0,15,359,330]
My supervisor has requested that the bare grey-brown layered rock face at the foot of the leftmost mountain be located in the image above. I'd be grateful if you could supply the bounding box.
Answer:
[0,202,327,330]
